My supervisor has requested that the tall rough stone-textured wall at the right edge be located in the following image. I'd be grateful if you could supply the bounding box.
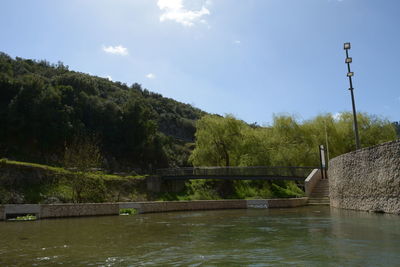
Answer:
[328,139,400,214]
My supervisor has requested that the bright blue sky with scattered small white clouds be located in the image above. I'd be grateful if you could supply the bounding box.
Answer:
[0,0,400,125]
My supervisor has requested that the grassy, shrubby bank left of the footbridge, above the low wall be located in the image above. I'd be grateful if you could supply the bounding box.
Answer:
[0,159,147,204]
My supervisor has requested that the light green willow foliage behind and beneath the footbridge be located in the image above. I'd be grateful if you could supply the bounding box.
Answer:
[190,112,396,199]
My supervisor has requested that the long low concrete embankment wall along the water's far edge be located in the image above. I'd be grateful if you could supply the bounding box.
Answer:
[0,197,307,220]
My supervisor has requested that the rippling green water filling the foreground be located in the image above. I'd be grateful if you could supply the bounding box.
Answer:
[0,207,400,266]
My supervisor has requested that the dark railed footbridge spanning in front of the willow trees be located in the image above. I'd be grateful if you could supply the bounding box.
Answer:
[156,166,319,182]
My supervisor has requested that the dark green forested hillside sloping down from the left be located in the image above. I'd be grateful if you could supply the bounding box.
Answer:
[0,53,205,171]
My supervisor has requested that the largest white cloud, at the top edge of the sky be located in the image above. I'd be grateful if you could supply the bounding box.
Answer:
[157,0,211,27]
